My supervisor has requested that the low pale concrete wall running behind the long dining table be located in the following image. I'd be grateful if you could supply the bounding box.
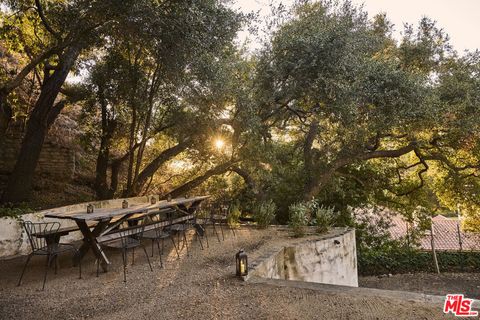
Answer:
[0,196,158,259]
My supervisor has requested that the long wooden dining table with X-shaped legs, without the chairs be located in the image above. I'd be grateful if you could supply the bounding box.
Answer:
[45,196,209,271]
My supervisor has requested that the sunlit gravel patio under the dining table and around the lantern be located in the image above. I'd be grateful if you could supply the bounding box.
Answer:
[0,228,454,320]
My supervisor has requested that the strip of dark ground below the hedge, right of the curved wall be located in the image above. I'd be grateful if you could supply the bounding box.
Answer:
[358,273,480,299]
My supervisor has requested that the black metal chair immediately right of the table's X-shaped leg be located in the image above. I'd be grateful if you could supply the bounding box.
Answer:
[97,224,153,282]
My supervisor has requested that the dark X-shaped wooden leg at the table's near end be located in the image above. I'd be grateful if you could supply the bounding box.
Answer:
[74,220,110,272]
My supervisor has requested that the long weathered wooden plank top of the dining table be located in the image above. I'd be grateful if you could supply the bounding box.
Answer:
[45,196,209,221]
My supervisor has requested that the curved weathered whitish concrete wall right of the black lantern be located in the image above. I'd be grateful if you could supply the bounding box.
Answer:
[247,230,358,287]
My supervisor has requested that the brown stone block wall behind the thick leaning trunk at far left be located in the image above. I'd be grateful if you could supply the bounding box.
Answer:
[0,129,75,190]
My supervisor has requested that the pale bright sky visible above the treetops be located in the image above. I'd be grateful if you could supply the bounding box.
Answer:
[232,0,480,53]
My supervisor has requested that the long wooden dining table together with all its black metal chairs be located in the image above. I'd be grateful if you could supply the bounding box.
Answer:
[18,196,235,290]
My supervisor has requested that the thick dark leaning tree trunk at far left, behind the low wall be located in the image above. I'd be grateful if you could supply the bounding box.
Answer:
[2,44,81,203]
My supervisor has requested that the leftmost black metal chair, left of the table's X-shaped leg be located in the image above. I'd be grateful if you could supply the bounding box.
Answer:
[17,221,82,290]
